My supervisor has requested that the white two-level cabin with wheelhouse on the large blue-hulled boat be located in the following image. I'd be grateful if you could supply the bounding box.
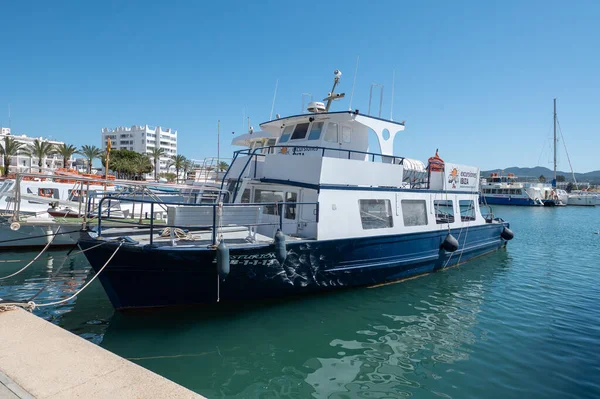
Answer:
[225,74,486,244]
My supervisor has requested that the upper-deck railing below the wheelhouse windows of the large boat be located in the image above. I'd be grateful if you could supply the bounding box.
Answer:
[221,144,404,201]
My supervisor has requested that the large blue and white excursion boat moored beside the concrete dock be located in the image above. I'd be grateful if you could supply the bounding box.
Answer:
[79,71,513,309]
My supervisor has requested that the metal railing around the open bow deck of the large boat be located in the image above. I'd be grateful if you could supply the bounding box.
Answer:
[97,196,319,245]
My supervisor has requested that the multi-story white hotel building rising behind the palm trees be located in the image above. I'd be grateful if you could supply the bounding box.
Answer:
[102,125,177,173]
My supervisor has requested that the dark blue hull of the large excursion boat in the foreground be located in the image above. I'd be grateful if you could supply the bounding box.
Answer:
[79,223,508,309]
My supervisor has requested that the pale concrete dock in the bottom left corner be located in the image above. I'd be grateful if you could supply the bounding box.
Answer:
[0,309,203,399]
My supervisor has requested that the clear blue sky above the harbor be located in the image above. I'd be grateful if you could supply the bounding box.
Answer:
[0,0,600,172]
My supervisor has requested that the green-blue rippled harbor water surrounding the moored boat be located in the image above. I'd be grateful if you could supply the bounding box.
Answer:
[0,207,600,399]
